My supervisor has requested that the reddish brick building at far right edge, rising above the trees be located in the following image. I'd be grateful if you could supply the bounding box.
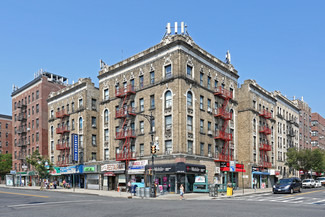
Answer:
[311,112,325,150]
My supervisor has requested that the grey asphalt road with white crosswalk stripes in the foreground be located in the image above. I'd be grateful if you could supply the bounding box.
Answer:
[0,188,325,217]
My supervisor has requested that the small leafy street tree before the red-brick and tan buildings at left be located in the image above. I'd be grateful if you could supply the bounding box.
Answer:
[26,150,54,179]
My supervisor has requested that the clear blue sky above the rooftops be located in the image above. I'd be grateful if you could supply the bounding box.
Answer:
[0,0,325,117]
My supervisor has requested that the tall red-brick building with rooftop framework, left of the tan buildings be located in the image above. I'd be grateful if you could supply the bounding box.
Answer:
[11,72,67,184]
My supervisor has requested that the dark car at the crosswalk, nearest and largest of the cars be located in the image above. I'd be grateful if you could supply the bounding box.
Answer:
[273,177,302,194]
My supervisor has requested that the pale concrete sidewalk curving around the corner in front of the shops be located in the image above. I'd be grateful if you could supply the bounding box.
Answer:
[0,184,272,200]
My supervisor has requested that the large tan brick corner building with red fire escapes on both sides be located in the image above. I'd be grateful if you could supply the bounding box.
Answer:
[98,23,240,192]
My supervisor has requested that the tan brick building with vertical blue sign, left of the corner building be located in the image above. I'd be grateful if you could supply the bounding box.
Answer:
[48,78,99,187]
